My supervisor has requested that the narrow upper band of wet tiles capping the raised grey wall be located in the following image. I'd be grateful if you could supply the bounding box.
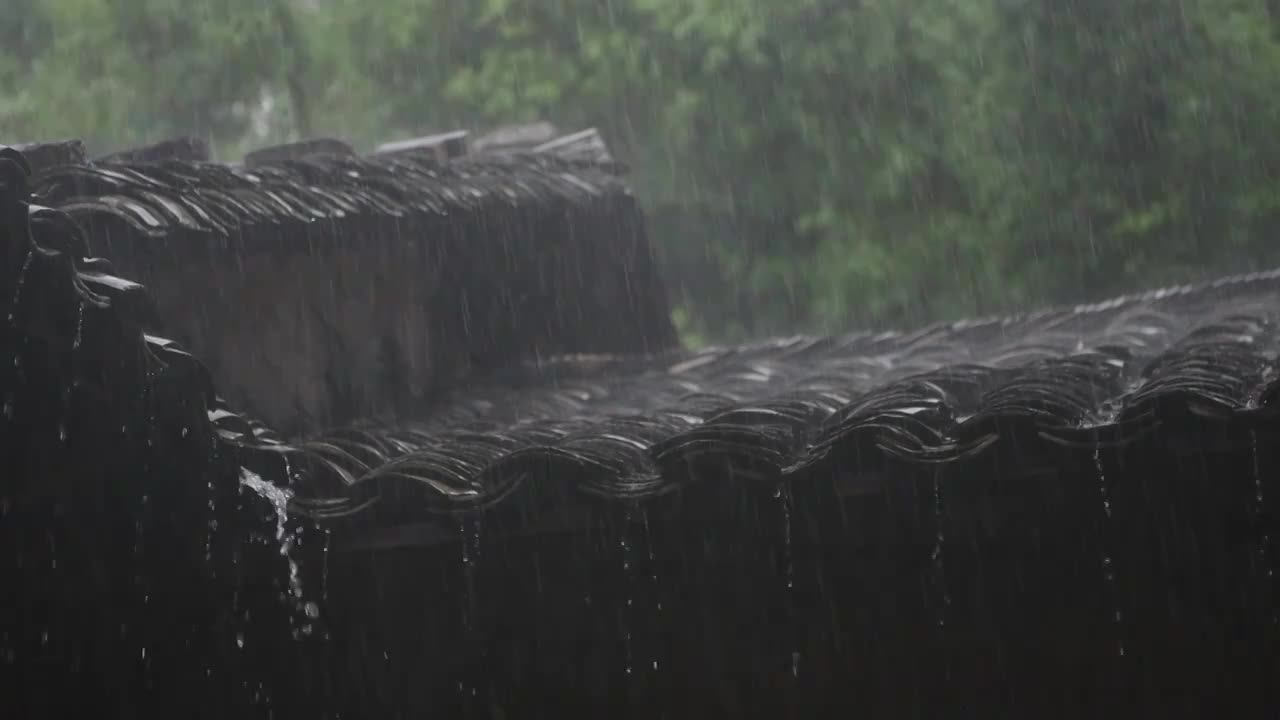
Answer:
[32,132,640,249]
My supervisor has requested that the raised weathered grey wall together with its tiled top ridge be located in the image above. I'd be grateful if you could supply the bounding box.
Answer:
[20,132,677,432]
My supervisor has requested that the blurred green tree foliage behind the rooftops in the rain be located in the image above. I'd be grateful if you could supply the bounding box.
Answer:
[0,0,1280,338]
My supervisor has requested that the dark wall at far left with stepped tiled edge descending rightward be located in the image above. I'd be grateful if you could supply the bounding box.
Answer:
[0,151,326,719]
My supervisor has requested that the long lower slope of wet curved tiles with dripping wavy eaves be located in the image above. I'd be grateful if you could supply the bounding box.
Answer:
[215,266,1280,524]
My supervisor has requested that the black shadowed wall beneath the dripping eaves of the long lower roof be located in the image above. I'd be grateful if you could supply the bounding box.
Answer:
[322,415,1280,717]
